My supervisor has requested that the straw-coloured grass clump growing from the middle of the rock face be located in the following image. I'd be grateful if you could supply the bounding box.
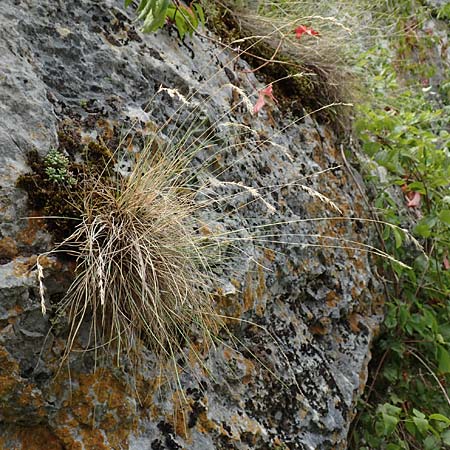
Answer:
[48,141,220,370]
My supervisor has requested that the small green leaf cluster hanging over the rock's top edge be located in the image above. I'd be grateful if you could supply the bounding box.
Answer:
[125,0,205,39]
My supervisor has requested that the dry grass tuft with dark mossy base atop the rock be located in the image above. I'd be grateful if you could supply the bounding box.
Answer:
[206,0,378,130]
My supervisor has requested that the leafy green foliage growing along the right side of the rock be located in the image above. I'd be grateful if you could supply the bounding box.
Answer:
[351,1,450,450]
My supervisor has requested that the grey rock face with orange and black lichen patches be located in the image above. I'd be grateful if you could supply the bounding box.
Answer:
[0,0,383,450]
